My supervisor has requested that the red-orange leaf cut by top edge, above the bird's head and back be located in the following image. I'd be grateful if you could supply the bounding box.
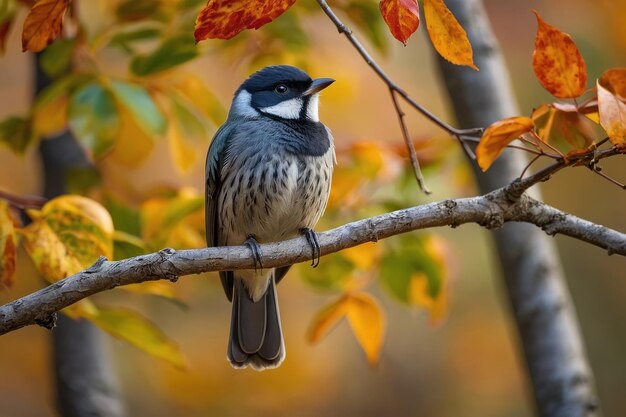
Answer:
[194,0,296,42]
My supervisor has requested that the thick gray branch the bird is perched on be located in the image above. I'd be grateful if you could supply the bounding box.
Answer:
[0,188,626,334]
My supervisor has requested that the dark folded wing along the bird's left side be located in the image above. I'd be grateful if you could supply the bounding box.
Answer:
[204,123,235,300]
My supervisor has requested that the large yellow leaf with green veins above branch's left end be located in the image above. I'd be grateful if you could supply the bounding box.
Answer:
[20,195,113,282]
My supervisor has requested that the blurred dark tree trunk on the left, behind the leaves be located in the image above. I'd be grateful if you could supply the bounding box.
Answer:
[34,54,123,417]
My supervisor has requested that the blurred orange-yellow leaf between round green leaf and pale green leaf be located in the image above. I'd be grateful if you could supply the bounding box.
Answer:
[107,106,154,168]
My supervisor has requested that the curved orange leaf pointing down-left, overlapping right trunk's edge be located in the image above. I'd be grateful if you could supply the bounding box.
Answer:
[476,117,535,171]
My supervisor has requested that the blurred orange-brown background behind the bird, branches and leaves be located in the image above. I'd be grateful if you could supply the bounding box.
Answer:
[0,0,626,417]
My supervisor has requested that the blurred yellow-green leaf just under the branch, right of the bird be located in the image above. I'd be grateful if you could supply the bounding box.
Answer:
[380,233,445,304]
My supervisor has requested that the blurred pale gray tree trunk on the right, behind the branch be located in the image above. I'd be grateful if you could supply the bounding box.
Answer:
[439,0,600,417]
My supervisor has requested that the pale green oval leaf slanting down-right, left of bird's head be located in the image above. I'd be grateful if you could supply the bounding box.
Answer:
[111,80,167,135]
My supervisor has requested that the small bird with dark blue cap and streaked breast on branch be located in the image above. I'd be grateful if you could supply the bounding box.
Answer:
[205,65,335,370]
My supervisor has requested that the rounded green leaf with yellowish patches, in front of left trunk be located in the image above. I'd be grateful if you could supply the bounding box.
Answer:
[69,83,120,158]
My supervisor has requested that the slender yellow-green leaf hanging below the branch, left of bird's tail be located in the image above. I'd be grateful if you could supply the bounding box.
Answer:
[87,307,187,368]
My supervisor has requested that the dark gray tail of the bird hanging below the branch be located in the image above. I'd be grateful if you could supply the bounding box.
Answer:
[228,273,285,371]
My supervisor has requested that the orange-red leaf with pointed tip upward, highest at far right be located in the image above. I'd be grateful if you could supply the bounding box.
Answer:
[533,10,587,98]
